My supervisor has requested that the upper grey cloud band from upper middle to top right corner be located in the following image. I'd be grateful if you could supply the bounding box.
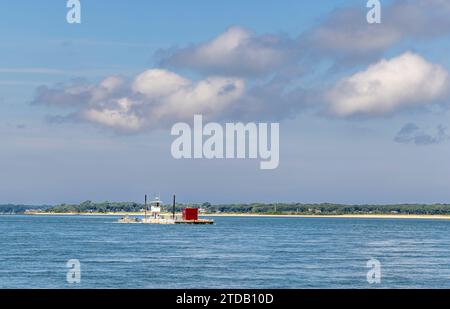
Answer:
[159,0,450,72]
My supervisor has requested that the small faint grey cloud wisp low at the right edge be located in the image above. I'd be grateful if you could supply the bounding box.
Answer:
[394,123,450,145]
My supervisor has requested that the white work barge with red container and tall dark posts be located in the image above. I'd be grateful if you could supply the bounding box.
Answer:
[118,195,214,224]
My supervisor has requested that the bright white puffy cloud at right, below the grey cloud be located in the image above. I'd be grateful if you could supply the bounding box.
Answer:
[327,52,449,116]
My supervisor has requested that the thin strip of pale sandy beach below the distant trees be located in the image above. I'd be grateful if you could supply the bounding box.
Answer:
[25,212,450,220]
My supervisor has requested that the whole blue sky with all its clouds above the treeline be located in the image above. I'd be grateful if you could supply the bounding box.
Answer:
[0,0,450,204]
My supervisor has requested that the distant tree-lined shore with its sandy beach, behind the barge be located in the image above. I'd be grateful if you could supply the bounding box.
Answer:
[0,201,450,219]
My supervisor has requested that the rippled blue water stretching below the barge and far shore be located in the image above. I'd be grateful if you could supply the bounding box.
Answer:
[0,216,450,288]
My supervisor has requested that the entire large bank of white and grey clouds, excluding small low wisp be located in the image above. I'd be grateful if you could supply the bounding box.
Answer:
[33,0,450,133]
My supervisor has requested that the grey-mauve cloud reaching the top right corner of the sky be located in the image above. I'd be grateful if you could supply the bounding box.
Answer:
[308,0,450,59]
